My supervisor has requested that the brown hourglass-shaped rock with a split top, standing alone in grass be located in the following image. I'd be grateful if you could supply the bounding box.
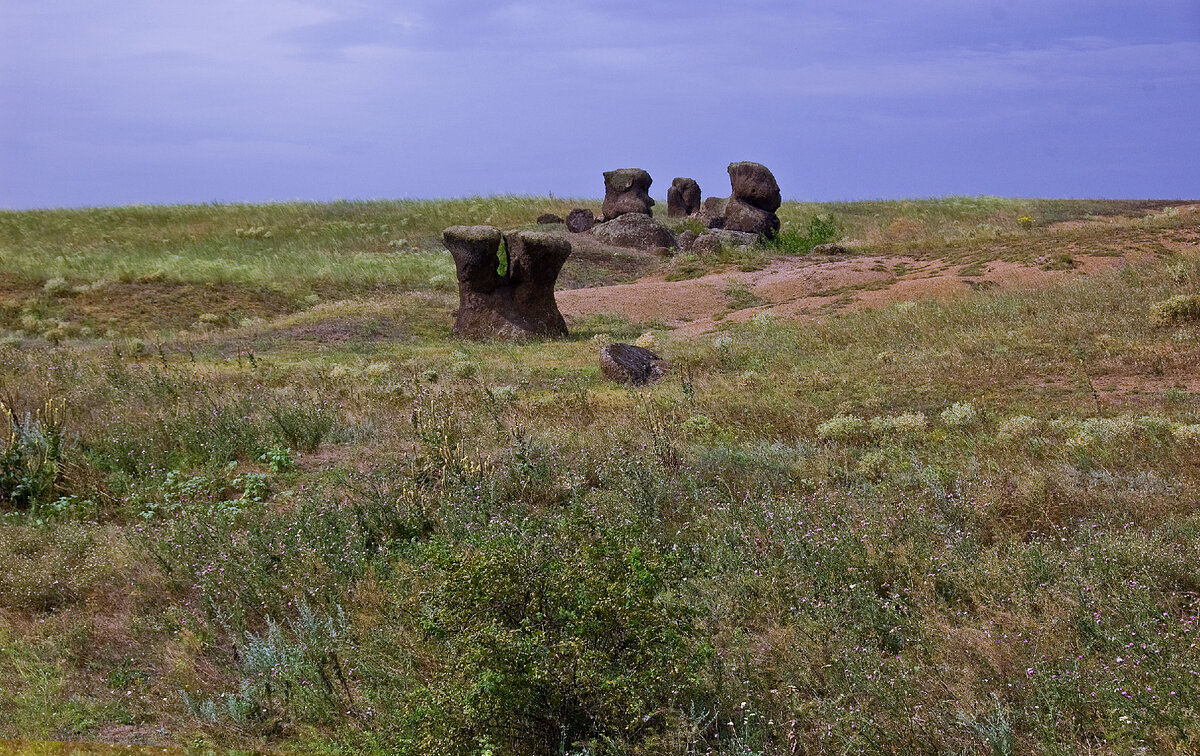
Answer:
[442,226,571,340]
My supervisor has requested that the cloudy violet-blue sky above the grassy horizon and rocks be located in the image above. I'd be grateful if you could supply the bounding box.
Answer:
[0,0,1200,209]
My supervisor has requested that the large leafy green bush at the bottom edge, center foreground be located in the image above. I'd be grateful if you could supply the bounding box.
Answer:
[397,522,704,754]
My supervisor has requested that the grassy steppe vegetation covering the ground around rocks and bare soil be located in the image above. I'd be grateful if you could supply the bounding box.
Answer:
[0,198,1200,755]
